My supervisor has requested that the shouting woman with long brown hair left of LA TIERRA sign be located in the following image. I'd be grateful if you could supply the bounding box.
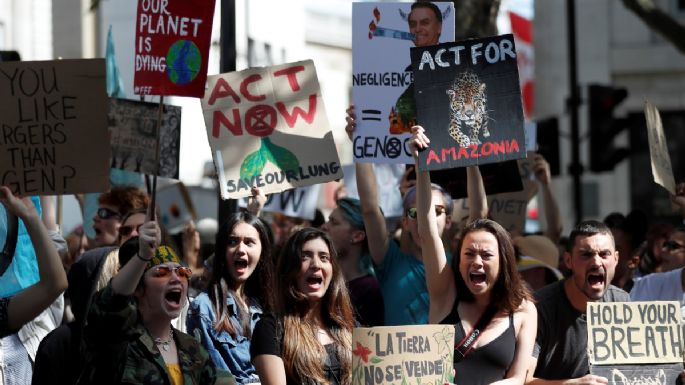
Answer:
[250,228,355,385]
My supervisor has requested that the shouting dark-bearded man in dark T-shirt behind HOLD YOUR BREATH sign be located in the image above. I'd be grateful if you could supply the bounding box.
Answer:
[526,221,630,385]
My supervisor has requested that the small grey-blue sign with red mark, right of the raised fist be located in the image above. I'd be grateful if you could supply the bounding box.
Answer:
[157,182,197,234]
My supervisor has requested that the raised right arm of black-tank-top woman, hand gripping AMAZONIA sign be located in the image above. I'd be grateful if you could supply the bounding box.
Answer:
[411,126,457,323]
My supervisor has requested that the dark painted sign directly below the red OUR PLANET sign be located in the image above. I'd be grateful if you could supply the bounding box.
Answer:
[108,99,181,179]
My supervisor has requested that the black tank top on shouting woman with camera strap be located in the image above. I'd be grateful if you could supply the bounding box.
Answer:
[440,301,516,385]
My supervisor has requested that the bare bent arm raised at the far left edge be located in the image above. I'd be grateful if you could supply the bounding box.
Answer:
[0,186,67,330]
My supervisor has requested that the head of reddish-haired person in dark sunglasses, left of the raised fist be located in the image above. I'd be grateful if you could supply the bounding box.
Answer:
[93,186,149,247]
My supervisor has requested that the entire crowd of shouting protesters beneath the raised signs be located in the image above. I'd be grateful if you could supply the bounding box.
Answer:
[0,3,685,385]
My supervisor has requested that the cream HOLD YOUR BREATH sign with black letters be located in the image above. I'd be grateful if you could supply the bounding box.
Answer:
[587,301,683,365]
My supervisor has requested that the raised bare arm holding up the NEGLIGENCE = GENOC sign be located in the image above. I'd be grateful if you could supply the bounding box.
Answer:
[345,106,389,265]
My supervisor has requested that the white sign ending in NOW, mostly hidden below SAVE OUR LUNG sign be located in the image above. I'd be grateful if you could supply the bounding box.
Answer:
[239,184,321,221]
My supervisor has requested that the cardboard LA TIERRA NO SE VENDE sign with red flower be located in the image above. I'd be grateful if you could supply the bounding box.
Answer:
[352,325,454,385]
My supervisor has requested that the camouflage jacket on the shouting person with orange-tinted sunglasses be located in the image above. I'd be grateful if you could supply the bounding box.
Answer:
[78,283,235,385]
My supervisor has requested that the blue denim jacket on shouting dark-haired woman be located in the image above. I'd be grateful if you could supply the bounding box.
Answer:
[186,292,262,384]
